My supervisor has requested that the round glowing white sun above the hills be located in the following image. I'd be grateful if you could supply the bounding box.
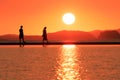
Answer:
[62,13,75,25]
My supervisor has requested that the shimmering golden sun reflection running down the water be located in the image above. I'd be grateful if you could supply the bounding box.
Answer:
[57,45,81,80]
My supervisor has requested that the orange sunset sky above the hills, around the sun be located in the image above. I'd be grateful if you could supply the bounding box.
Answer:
[0,0,120,35]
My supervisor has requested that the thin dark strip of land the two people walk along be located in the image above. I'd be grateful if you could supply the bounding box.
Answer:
[0,42,120,45]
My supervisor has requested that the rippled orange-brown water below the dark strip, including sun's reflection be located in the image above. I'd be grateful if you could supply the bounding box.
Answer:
[0,45,120,80]
